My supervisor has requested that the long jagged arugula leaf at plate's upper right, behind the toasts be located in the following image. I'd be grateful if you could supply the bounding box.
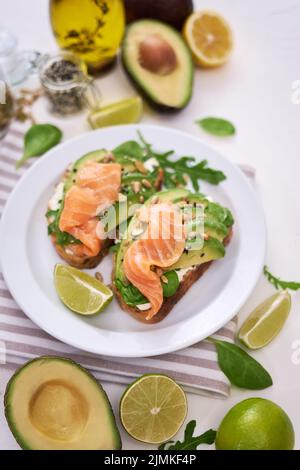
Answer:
[138,132,226,191]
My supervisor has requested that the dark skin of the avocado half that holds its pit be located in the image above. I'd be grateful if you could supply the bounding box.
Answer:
[121,20,194,113]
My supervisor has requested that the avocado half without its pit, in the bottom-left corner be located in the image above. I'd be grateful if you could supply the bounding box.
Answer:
[4,356,122,450]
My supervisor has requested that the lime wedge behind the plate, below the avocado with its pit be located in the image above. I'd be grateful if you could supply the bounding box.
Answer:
[88,96,143,129]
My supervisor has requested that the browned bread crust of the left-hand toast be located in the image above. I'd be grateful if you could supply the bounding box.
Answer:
[51,169,164,269]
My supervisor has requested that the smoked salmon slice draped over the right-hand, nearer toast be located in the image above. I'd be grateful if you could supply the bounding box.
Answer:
[124,203,186,320]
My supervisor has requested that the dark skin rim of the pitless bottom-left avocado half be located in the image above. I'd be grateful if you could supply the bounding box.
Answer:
[4,356,122,450]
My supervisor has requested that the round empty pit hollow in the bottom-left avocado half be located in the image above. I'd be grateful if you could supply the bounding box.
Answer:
[29,380,89,441]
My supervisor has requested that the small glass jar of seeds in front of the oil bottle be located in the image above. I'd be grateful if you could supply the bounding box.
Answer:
[39,52,100,116]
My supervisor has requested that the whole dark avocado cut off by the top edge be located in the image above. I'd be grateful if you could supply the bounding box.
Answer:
[125,0,194,30]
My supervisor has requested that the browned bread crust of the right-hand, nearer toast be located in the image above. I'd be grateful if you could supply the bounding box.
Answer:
[112,229,233,324]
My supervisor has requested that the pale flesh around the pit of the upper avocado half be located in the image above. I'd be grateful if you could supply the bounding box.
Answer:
[122,20,194,109]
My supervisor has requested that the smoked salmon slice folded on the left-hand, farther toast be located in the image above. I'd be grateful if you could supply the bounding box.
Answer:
[59,161,121,257]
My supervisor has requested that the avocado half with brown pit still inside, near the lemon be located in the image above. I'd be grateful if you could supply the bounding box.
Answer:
[122,20,194,111]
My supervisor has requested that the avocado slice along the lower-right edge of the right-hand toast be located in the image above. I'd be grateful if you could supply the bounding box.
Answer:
[167,238,225,271]
